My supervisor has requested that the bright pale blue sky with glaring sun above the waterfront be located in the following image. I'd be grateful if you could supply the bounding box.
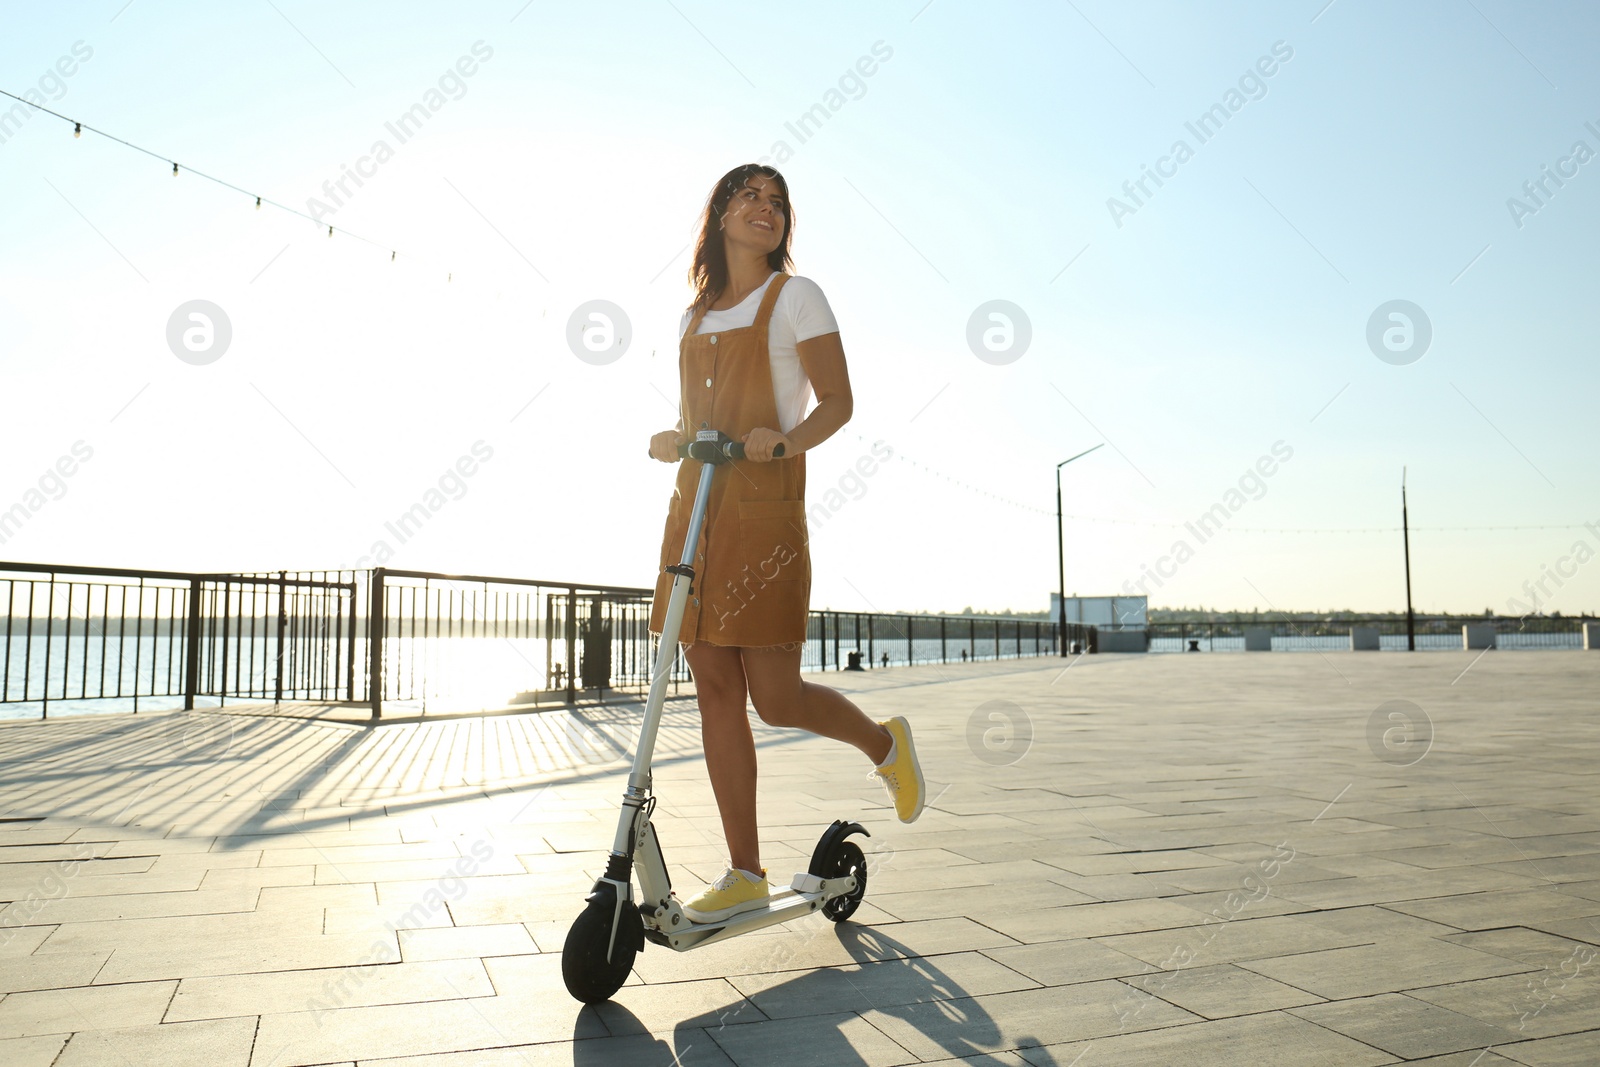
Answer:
[0,0,1600,614]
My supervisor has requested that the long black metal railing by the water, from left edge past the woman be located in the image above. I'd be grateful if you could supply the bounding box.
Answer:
[0,563,1075,718]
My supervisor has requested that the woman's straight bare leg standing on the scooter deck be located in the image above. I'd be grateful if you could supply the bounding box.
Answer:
[683,643,762,873]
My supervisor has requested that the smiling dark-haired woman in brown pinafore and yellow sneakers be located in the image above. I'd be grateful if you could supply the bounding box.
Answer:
[650,163,923,923]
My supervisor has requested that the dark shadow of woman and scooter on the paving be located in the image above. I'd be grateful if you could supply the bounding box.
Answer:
[573,920,1054,1067]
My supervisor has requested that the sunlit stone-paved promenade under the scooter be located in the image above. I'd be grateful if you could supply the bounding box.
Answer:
[0,651,1600,1067]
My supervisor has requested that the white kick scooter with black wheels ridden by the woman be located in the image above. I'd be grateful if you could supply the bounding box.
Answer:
[562,429,870,1005]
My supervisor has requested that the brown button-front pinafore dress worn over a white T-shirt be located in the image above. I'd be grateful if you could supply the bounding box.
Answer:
[650,274,811,648]
